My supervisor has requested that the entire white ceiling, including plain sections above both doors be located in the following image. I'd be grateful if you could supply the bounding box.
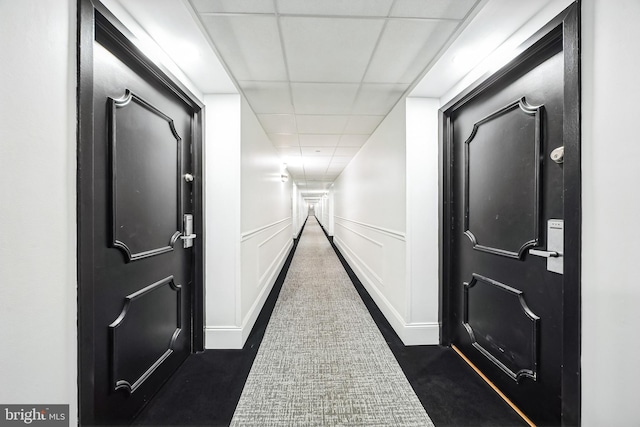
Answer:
[103,0,568,195]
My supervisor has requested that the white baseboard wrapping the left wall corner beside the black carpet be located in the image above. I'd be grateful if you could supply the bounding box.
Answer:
[204,240,294,350]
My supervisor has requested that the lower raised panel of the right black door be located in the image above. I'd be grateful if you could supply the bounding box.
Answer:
[463,273,540,381]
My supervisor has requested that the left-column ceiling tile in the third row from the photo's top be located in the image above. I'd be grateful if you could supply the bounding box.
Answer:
[239,81,293,114]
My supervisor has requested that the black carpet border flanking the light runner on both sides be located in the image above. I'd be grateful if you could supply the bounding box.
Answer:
[134,217,526,427]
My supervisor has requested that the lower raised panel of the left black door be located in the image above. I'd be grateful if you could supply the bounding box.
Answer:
[109,276,182,393]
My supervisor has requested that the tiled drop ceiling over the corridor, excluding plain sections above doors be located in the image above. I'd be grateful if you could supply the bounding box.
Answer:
[189,0,479,190]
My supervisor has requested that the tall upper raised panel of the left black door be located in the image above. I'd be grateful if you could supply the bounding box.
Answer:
[109,90,182,262]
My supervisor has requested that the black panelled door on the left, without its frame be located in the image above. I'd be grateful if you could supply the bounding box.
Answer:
[93,42,192,420]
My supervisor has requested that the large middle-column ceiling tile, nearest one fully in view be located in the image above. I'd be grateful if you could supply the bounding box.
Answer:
[280,17,384,82]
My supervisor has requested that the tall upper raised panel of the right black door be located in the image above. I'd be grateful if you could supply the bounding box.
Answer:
[464,98,543,259]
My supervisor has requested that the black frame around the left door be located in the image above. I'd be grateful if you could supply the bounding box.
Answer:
[77,0,204,425]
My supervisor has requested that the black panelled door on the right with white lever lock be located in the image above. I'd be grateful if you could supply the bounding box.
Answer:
[444,5,580,425]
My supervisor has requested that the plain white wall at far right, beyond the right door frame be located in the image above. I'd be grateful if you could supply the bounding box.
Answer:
[582,0,640,427]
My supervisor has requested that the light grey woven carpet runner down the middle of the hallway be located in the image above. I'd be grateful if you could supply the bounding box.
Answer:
[231,218,433,427]
